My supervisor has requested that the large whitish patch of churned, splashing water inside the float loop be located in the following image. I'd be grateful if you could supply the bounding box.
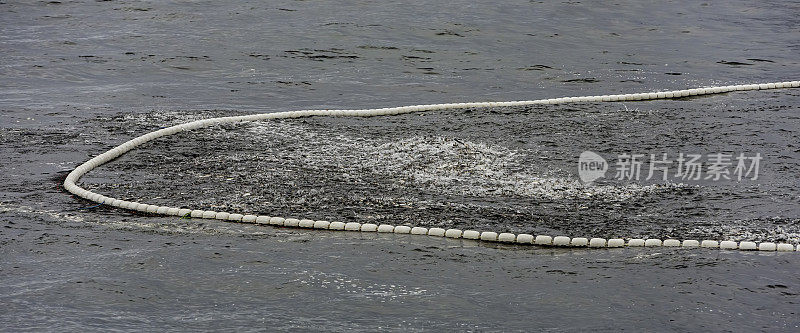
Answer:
[248,122,686,201]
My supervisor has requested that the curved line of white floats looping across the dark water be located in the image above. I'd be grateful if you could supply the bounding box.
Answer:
[64,81,800,252]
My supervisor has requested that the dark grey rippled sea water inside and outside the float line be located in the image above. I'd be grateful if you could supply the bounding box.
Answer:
[0,1,800,331]
